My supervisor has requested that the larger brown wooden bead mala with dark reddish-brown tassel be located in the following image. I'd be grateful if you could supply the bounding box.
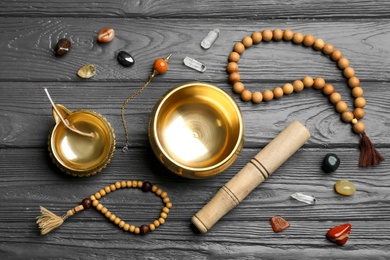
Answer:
[226,29,384,167]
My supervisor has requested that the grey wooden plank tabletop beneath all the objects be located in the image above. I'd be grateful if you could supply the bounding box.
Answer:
[0,0,390,259]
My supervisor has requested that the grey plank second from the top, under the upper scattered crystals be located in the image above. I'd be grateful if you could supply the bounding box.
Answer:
[0,17,390,81]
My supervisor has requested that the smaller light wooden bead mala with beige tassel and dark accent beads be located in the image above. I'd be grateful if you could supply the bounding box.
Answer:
[37,180,172,235]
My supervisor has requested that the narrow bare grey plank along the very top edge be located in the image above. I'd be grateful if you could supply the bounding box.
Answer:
[0,0,390,19]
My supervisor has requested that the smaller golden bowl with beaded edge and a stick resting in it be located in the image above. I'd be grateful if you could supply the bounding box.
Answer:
[48,104,116,177]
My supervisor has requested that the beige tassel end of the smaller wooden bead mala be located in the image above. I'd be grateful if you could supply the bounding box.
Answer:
[37,205,84,235]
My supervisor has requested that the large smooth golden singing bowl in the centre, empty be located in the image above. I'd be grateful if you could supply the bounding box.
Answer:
[149,82,244,179]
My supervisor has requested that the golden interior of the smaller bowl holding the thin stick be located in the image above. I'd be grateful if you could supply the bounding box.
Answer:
[51,111,112,172]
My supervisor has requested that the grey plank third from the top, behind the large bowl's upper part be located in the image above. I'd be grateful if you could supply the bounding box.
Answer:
[0,81,390,149]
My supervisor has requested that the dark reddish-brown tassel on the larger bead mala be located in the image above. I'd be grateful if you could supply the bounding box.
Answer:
[359,132,385,167]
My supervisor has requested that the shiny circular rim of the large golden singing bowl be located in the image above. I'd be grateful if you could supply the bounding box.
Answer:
[149,82,245,174]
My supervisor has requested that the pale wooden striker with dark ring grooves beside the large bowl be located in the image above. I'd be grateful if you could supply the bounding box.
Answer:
[192,121,310,233]
